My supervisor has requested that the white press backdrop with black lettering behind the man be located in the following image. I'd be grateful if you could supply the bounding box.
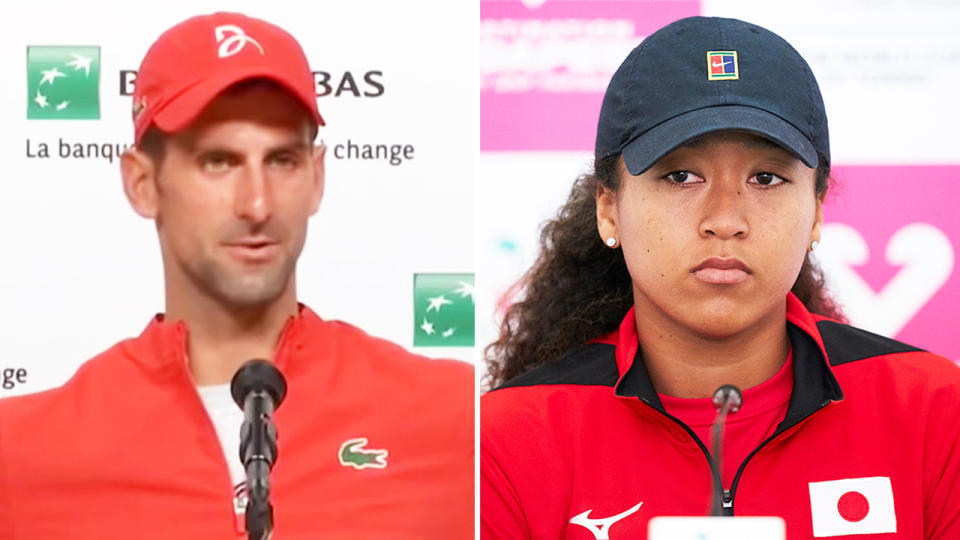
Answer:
[0,0,477,397]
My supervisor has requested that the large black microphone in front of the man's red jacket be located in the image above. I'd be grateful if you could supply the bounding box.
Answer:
[230,360,287,540]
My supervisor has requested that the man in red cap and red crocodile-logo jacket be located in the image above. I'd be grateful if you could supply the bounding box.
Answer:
[0,13,474,540]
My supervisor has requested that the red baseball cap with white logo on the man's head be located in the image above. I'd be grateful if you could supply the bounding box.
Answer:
[133,13,324,143]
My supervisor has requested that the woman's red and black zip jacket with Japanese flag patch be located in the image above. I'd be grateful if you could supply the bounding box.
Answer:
[480,294,960,540]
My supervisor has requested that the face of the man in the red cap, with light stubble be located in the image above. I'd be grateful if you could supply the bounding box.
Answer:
[146,85,323,309]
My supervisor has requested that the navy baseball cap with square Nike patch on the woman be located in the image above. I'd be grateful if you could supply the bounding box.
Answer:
[596,17,830,175]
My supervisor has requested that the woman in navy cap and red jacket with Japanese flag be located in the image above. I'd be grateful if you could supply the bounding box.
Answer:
[481,17,960,540]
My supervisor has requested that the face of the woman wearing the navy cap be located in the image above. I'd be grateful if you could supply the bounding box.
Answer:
[597,132,823,338]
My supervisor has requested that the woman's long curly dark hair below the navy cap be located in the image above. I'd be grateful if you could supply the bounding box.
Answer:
[484,155,844,388]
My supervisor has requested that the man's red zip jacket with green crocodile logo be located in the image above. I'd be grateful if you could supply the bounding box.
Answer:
[0,307,474,540]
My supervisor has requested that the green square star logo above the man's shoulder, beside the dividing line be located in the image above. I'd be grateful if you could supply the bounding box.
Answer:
[413,274,474,347]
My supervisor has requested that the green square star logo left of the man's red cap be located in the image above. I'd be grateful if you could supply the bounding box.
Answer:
[27,46,100,120]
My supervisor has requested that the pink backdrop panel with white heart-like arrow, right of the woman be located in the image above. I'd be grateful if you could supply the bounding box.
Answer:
[821,165,960,359]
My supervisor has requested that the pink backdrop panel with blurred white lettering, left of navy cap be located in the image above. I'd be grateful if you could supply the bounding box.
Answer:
[480,0,700,151]
